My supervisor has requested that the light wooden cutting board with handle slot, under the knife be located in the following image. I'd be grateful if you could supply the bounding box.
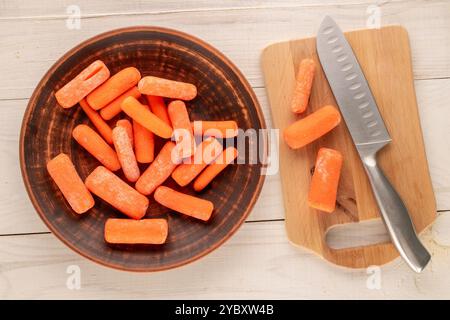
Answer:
[262,26,436,268]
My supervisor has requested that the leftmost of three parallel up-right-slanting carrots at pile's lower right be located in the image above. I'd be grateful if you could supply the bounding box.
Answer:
[136,141,179,195]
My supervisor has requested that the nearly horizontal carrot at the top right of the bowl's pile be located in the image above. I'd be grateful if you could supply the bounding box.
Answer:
[138,76,197,100]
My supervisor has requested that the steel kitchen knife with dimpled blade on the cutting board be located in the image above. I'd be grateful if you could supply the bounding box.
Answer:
[316,16,430,272]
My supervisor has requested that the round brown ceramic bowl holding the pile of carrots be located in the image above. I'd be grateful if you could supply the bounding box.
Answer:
[20,27,265,271]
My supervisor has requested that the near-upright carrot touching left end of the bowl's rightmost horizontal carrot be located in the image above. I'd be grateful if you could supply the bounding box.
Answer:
[167,100,195,158]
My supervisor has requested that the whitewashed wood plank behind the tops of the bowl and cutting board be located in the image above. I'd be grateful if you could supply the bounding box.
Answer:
[0,0,450,99]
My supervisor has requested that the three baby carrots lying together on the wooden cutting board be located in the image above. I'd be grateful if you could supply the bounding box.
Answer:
[284,59,343,213]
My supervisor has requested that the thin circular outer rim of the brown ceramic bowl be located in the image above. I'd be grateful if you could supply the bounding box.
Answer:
[19,25,267,272]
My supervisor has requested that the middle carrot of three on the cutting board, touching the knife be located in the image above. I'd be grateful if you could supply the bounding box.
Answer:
[284,106,341,149]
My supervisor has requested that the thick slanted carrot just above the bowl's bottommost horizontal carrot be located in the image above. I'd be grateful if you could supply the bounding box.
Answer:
[84,166,149,219]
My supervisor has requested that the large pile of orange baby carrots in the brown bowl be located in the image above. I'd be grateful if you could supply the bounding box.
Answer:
[47,60,238,244]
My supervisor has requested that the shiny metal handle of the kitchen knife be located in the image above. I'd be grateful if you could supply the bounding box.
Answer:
[362,153,431,273]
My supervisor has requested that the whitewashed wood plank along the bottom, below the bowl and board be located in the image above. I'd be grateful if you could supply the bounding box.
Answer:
[0,222,450,299]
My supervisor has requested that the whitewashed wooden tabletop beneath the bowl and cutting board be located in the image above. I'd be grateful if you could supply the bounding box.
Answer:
[0,0,450,299]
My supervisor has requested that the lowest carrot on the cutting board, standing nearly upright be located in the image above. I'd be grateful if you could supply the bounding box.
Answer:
[308,148,342,213]
